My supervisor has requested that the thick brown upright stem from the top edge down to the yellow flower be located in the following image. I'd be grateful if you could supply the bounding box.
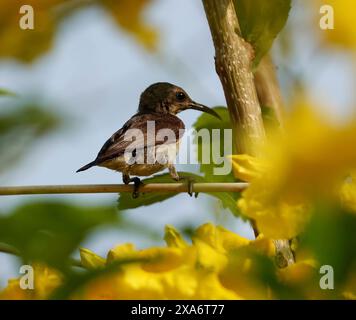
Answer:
[203,0,265,155]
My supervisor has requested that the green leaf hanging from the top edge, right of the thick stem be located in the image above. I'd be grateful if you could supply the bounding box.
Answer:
[234,0,292,68]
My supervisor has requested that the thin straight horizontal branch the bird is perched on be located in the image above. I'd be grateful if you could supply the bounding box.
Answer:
[0,182,248,196]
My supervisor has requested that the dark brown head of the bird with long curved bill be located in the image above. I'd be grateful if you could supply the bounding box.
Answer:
[138,82,221,119]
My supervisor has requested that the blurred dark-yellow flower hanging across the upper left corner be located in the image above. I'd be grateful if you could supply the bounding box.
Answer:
[0,0,157,62]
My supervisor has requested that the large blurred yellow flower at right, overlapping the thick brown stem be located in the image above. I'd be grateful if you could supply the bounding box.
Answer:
[232,103,356,239]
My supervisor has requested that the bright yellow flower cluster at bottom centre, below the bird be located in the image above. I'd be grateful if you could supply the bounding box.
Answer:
[76,224,249,299]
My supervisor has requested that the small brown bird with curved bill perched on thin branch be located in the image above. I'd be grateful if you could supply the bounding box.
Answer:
[76,82,221,198]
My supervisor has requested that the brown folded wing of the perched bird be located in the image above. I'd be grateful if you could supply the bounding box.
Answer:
[95,113,184,164]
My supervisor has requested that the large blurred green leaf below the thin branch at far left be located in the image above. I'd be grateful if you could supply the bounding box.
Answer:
[0,202,117,270]
